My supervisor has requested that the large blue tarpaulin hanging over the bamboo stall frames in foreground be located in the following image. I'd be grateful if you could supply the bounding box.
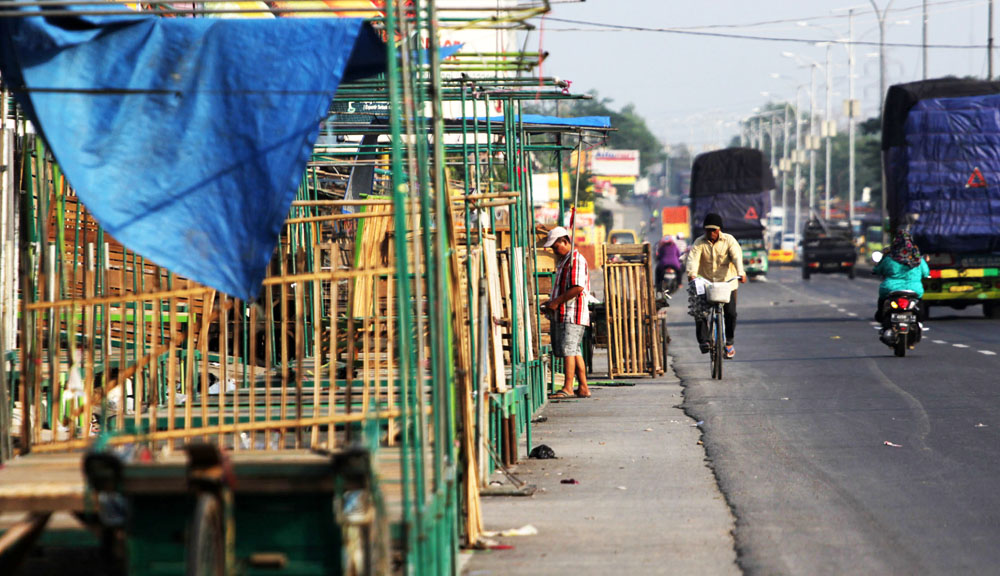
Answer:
[0,8,385,299]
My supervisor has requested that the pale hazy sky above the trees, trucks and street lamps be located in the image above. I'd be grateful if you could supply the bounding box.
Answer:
[528,0,1000,152]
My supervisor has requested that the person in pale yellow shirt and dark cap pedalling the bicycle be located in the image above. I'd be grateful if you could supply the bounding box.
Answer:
[687,213,747,358]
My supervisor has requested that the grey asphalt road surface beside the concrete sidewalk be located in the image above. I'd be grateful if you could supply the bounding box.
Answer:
[671,269,1000,575]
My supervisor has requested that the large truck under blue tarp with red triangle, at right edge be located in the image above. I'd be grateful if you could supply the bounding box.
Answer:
[882,78,1000,318]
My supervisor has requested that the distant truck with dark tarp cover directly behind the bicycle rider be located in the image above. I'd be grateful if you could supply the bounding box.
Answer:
[691,148,774,276]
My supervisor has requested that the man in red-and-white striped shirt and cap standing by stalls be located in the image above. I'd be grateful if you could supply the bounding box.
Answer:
[543,226,590,398]
